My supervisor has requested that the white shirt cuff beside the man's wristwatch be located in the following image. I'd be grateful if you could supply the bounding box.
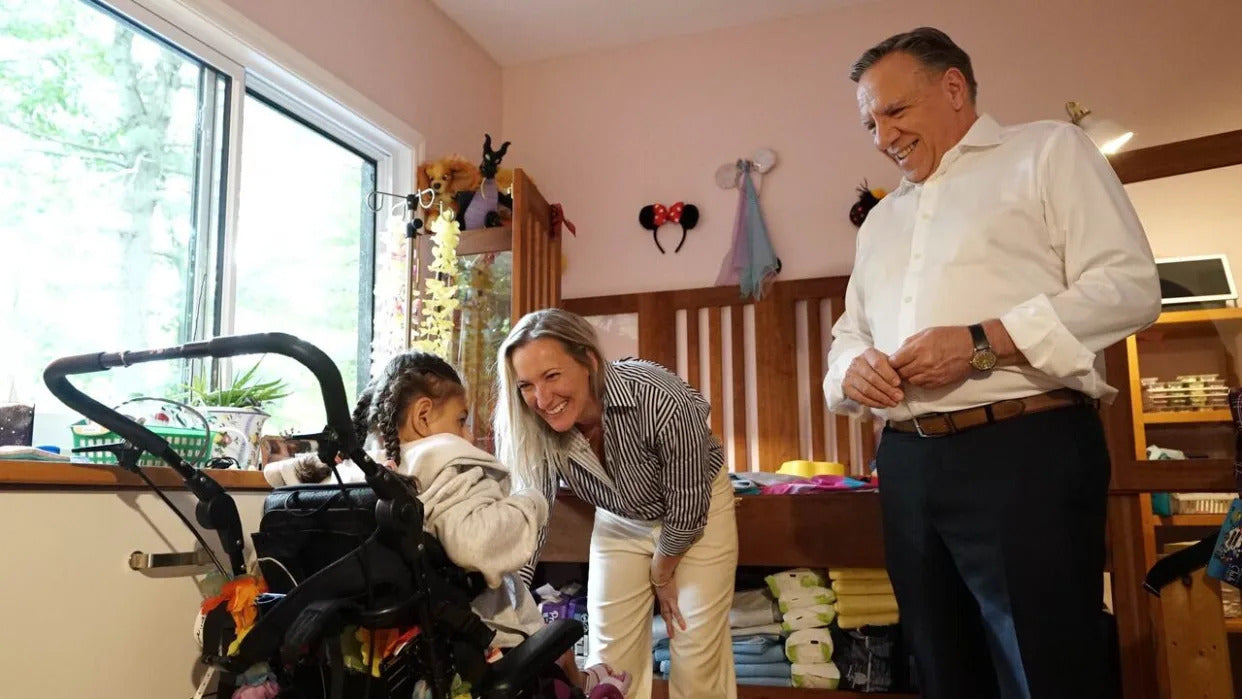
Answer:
[1000,294,1095,379]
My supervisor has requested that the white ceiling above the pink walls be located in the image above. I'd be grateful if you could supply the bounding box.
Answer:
[431,0,862,66]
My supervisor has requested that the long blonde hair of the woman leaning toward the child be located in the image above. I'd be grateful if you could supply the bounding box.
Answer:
[492,308,607,488]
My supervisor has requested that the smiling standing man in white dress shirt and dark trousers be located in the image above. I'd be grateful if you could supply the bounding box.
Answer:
[825,27,1160,699]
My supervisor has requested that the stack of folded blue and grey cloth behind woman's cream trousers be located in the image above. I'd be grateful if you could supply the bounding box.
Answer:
[651,590,792,687]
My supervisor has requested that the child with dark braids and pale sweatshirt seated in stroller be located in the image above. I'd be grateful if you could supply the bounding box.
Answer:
[263,351,630,698]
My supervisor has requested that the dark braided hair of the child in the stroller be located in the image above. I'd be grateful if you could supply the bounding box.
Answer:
[354,351,466,466]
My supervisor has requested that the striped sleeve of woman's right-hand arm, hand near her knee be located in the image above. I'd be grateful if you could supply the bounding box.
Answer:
[656,395,713,556]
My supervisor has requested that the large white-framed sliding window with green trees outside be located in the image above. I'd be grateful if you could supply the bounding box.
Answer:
[0,0,421,444]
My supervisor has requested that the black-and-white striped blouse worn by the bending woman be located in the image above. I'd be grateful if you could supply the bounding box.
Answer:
[522,359,724,582]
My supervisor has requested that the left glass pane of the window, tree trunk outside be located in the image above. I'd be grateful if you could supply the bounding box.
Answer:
[0,0,229,404]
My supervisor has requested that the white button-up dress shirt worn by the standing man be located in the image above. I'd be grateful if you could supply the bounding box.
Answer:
[823,114,1160,420]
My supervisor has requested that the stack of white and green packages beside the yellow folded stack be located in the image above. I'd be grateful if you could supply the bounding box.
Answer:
[766,569,841,689]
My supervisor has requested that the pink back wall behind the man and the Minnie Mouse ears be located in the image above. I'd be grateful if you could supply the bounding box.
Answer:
[503,0,1242,297]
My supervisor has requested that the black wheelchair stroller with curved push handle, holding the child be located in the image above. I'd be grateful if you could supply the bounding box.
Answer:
[43,333,582,699]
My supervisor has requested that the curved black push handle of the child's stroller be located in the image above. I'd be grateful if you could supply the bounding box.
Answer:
[43,333,367,575]
